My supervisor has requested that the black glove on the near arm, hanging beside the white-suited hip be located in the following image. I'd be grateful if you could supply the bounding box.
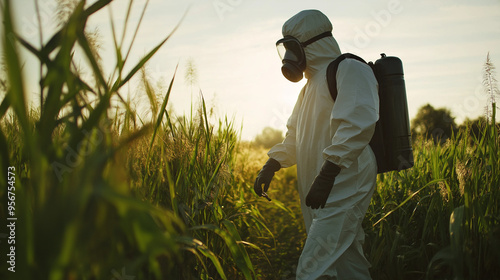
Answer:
[306,160,340,209]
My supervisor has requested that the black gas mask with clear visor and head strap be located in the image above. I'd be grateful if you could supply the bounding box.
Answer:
[276,31,332,83]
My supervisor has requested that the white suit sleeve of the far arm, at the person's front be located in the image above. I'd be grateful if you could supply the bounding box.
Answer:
[267,88,305,167]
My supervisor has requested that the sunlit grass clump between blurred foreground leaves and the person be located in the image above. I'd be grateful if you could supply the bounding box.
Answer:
[128,87,261,279]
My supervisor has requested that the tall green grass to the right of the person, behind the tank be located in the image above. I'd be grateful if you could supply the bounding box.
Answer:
[365,117,500,279]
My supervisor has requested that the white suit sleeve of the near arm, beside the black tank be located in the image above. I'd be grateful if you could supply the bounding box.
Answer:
[323,59,379,168]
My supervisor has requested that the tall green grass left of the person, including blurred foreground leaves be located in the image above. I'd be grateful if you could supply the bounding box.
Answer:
[0,0,261,279]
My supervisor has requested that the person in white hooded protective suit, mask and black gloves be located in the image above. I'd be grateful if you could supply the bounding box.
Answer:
[254,10,379,280]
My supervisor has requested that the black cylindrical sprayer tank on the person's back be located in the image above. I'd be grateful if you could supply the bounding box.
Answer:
[374,54,414,173]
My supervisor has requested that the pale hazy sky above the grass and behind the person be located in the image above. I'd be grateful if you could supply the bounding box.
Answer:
[6,0,500,140]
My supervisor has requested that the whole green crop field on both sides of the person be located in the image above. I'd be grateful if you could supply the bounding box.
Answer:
[0,0,500,280]
